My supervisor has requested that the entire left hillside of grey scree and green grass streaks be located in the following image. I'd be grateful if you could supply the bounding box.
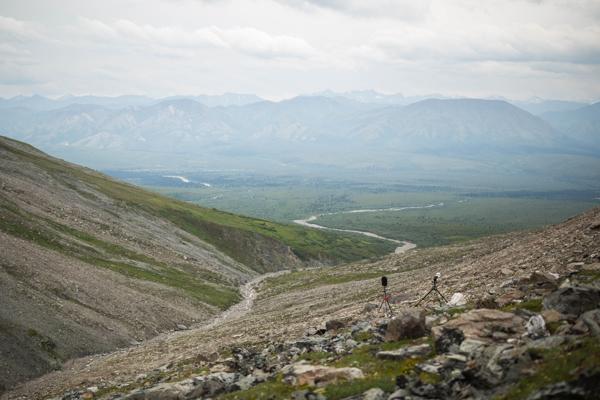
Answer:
[0,137,390,386]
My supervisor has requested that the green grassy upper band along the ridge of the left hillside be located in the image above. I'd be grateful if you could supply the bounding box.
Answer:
[0,138,394,272]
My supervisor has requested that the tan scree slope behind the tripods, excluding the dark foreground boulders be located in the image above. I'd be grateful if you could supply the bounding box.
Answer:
[2,208,600,400]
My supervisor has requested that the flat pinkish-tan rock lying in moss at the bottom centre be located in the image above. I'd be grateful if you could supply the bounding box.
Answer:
[281,362,365,386]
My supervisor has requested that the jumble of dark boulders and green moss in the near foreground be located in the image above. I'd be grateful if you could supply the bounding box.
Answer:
[57,263,600,400]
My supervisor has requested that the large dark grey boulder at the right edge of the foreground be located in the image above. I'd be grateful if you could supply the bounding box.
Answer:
[543,286,600,317]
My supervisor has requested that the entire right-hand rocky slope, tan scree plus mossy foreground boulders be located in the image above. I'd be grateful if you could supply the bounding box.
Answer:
[4,209,600,399]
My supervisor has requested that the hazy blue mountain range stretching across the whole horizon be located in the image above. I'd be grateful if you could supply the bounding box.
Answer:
[0,91,600,185]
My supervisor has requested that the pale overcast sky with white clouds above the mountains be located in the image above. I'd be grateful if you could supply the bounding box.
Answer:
[0,0,600,101]
